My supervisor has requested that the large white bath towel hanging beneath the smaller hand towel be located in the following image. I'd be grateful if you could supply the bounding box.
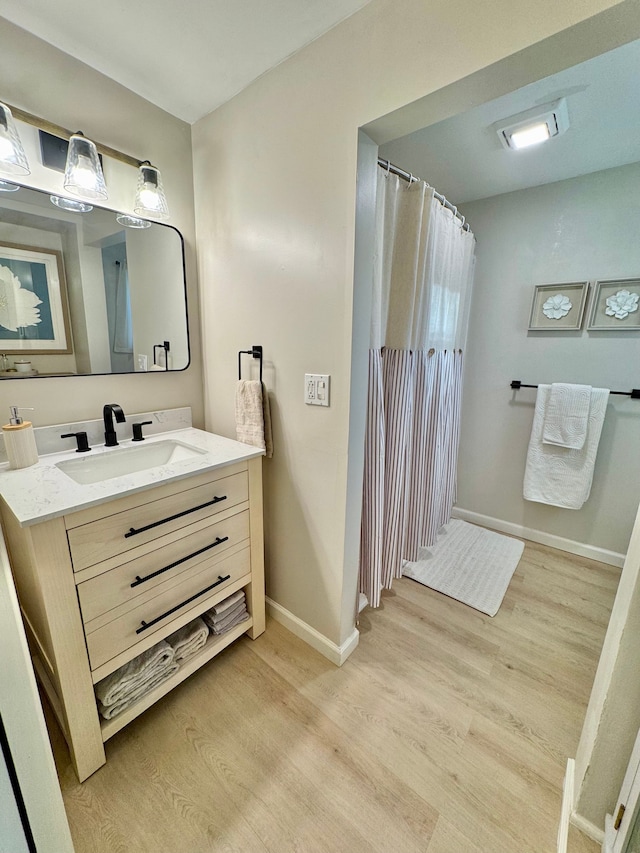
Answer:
[524,385,609,509]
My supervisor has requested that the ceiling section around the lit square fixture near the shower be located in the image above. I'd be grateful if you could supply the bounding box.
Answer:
[380,42,640,204]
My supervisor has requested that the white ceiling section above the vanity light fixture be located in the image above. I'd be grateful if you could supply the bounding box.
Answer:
[0,0,369,122]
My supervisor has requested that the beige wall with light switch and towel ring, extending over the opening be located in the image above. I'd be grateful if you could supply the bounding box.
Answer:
[193,0,632,644]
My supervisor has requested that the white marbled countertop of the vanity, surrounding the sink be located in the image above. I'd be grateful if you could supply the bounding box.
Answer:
[0,428,264,527]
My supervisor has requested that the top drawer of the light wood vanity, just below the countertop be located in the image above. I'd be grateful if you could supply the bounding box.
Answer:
[67,471,249,572]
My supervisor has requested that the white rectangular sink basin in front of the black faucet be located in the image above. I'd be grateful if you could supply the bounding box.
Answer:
[56,439,206,486]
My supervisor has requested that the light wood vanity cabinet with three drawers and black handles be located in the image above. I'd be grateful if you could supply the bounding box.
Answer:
[2,457,265,781]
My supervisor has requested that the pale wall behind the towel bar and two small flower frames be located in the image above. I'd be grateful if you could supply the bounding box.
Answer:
[458,164,640,553]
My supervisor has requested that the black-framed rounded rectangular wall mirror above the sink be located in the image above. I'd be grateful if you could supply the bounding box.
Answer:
[0,186,189,379]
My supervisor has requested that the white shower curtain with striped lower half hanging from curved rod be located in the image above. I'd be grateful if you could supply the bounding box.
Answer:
[360,169,475,607]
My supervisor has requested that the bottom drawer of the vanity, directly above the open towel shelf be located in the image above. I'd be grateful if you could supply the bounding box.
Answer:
[85,547,251,669]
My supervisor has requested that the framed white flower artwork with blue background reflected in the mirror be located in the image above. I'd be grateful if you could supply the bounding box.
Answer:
[0,243,72,355]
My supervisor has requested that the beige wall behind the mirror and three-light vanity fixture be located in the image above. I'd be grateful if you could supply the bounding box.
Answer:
[0,19,203,426]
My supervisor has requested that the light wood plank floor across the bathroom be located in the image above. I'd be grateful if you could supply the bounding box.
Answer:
[50,544,619,853]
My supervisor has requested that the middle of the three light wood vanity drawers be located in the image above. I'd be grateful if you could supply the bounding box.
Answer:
[78,510,249,624]
